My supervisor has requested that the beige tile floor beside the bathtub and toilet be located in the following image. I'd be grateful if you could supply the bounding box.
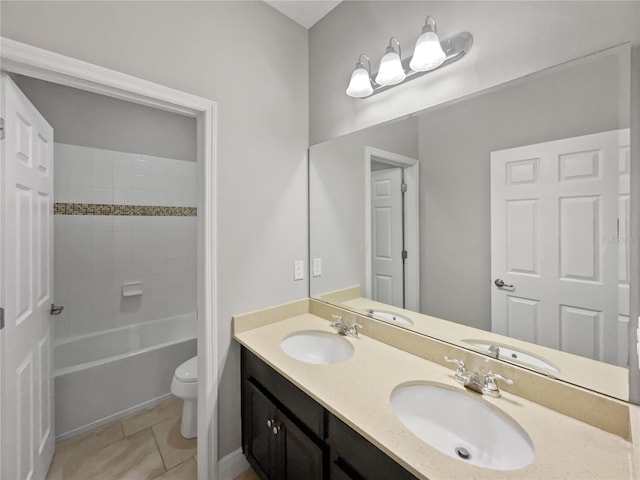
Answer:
[47,398,259,480]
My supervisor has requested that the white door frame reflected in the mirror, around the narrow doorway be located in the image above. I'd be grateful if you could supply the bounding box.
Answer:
[364,146,420,312]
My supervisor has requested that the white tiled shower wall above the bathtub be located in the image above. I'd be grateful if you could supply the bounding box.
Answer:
[54,143,197,342]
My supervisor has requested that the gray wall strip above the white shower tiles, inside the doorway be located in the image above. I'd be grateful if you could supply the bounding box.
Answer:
[13,75,196,162]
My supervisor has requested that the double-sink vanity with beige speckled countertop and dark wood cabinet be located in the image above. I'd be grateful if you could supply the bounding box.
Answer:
[234,299,633,480]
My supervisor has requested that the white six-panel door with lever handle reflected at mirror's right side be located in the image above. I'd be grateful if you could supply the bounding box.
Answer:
[491,130,629,363]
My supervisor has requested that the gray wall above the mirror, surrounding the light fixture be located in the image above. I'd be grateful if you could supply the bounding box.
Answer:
[309,0,640,144]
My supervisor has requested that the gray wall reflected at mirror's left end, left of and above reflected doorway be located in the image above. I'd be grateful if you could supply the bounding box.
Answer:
[309,118,418,295]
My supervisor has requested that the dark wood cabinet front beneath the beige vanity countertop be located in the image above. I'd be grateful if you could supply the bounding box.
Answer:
[241,347,416,480]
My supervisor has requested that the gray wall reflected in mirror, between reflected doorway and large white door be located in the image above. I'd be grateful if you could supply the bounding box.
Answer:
[419,52,629,330]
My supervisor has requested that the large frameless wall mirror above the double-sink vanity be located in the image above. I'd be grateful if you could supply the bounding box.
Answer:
[309,45,630,400]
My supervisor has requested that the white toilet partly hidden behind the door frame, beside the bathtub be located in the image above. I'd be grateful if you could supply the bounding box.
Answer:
[171,356,198,438]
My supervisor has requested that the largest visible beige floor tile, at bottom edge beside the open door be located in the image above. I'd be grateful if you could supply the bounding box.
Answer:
[62,429,165,480]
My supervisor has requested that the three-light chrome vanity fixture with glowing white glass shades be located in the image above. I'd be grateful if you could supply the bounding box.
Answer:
[347,15,473,98]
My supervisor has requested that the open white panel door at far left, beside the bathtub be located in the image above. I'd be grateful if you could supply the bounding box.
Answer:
[0,74,55,480]
